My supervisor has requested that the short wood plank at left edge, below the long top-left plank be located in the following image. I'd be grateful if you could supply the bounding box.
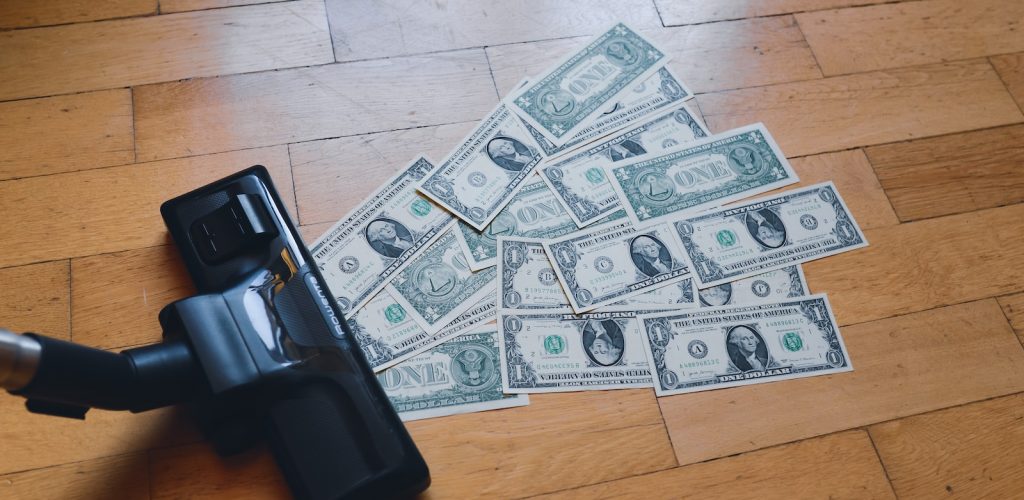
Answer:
[0,89,135,180]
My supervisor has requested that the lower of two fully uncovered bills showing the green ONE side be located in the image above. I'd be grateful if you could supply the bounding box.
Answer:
[604,123,800,223]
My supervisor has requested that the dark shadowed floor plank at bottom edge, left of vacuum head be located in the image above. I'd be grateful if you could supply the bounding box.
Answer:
[150,443,292,500]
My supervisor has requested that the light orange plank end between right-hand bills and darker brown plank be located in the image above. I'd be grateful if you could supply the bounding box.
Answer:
[774,150,899,230]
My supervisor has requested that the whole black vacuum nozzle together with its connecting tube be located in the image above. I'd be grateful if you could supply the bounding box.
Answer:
[0,166,430,499]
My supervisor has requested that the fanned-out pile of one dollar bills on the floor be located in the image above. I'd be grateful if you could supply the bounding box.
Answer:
[312,23,867,420]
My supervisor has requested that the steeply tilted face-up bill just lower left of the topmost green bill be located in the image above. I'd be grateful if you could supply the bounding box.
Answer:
[419,102,545,231]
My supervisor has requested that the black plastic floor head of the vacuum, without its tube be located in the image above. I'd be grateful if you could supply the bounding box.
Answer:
[161,166,430,499]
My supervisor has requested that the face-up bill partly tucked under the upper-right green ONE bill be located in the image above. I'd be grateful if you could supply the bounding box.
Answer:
[539,105,709,227]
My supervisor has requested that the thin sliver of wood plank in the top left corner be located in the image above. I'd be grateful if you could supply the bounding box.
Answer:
[0,0,157,30]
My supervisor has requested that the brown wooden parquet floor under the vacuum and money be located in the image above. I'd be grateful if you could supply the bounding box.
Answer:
[0,0,1024,499]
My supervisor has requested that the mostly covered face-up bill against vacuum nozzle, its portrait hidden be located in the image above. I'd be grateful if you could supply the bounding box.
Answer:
[348,290,497,372]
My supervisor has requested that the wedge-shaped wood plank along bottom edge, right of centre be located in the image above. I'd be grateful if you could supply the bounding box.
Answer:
[542,430,896,499]
